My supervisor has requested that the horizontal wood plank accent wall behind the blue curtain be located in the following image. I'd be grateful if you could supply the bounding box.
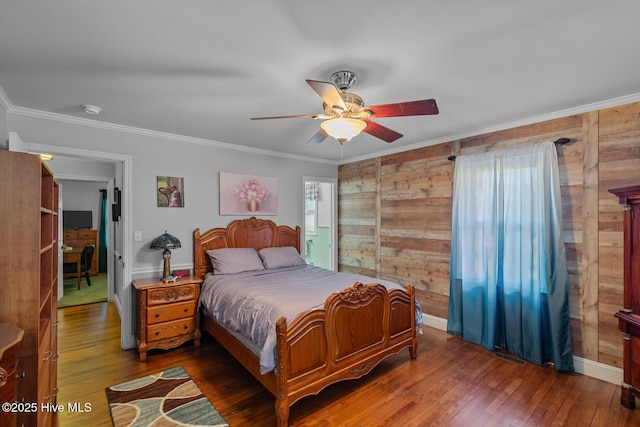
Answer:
[338,103,640,367]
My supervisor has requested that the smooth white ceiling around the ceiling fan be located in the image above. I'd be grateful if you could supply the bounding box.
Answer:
[0,0,640,162]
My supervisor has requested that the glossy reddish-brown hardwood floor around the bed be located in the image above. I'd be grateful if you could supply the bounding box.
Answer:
[55,303,640,427]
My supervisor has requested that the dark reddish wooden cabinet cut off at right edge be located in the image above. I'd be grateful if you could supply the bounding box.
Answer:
[609,185,640,409]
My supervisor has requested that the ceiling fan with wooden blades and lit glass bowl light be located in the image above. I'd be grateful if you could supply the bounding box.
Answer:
[251,71,438,144]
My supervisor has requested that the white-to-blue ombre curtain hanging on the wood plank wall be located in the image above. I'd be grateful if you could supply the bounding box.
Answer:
[447,142,573,371]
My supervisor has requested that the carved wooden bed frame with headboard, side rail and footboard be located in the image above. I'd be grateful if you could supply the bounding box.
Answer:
[193,217,417,426]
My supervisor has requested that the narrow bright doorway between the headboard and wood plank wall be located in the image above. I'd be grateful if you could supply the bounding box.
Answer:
[302,177,337,270]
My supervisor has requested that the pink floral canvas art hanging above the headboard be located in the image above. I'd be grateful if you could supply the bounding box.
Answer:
[220,172,278,215]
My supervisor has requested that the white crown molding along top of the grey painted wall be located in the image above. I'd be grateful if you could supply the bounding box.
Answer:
[7,103,338,165]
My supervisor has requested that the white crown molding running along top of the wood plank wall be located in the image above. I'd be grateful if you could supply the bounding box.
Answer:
[339,92,640,165]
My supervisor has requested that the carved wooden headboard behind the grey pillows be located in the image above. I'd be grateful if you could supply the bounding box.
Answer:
[193,216,300,278]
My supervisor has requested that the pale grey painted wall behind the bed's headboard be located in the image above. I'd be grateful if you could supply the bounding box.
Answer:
[7,112,337,278]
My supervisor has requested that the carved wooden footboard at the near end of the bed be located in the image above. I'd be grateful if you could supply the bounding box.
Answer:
[276,283,417,426]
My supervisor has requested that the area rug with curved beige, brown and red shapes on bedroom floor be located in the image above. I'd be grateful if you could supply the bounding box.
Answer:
[105,366,229,427]
